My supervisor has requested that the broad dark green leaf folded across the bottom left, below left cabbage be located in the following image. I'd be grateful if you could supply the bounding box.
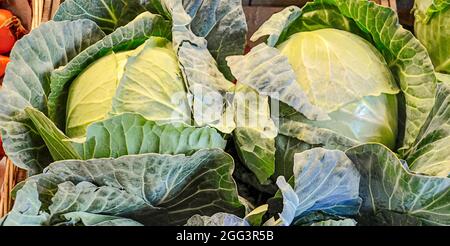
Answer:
[3,149,243,225]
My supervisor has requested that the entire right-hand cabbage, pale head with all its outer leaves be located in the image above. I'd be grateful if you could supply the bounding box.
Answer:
[229,0,450,225]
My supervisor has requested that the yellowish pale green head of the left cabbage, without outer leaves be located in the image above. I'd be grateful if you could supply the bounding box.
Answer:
[66,37,184,138]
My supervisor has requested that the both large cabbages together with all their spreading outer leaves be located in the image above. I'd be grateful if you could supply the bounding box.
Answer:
[0,0,450,226]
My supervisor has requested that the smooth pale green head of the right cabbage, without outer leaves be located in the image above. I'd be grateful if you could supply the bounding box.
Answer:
[278,29,398,148]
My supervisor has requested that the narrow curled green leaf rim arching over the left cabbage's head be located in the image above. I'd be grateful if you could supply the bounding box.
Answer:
[48,12,171,129]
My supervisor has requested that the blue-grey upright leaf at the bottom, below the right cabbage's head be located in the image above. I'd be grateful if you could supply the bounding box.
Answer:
[277,148,361,225]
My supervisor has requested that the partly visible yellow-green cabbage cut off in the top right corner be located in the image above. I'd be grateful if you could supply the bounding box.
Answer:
[414,0,450,74]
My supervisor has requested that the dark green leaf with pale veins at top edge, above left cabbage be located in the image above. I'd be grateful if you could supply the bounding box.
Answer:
[53,0,146,33]
